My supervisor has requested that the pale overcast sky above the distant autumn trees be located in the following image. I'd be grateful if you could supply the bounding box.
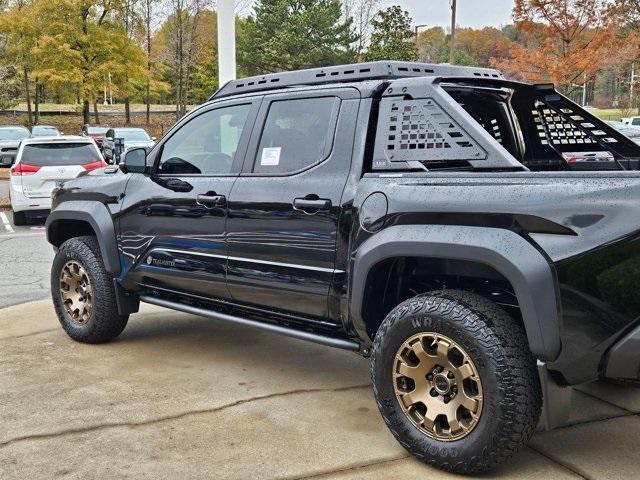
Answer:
[382,0,514,28]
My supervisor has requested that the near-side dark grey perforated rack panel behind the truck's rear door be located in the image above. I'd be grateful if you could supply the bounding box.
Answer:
[374,98,486,169]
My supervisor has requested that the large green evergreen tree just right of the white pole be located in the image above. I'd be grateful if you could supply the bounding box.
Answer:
[238,0,357,75]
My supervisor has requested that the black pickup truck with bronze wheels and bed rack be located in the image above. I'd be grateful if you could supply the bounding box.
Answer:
[47,62,640,473]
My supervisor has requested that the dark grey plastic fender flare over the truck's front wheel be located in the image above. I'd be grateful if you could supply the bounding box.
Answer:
[45,200,120,277]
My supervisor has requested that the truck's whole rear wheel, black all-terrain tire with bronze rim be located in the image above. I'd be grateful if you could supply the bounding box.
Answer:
[371,290,542,473]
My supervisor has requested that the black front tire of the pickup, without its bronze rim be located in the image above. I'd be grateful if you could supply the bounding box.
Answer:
[51,236,129,343]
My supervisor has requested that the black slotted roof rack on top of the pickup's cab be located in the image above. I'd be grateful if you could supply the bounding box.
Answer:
[209,61,504,100]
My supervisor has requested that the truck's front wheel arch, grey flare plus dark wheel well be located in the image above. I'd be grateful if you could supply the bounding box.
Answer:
[45,201,120,276]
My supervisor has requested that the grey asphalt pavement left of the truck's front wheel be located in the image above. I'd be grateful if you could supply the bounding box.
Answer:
[0,180,53,308]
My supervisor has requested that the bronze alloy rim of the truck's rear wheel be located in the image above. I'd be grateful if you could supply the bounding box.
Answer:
[393,332,482,442]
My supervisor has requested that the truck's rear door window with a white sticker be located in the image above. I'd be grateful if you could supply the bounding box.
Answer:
[253,97,340,173]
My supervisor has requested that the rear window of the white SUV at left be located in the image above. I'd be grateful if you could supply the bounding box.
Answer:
[21,143,102,167]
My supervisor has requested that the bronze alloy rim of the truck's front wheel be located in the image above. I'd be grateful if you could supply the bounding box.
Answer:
[60,260,93,325]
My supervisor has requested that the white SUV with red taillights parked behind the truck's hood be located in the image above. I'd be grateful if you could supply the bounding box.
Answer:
[9,136,107,225]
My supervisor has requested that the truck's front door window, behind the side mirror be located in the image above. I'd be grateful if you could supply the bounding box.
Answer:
[158,104,251,175]
